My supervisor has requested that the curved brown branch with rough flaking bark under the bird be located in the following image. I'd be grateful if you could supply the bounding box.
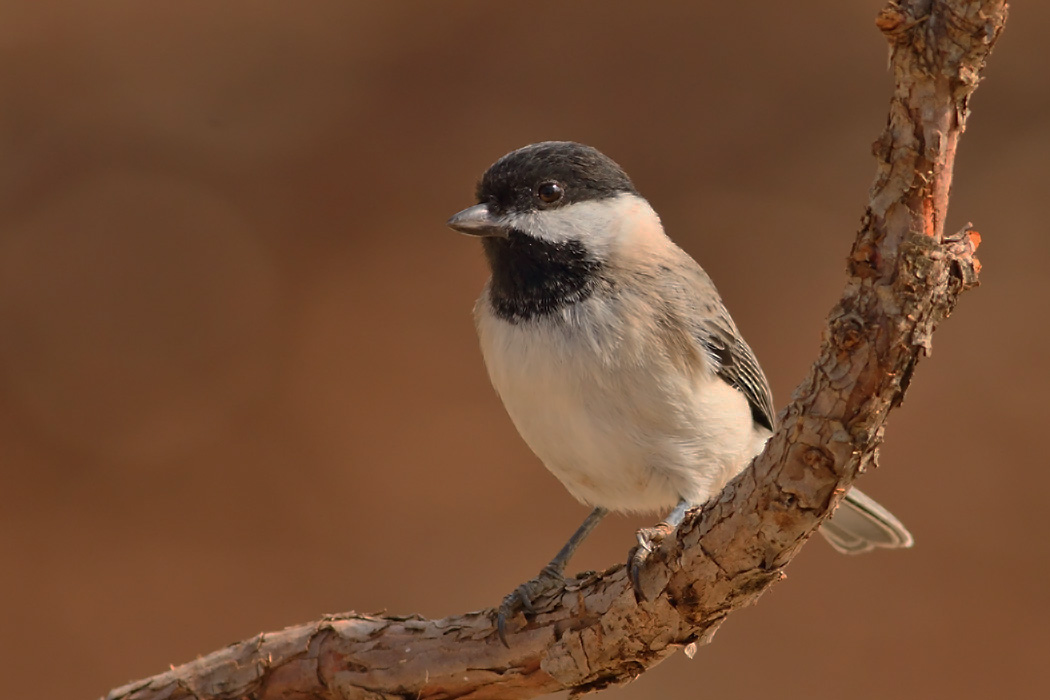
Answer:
[102,0,1006,700]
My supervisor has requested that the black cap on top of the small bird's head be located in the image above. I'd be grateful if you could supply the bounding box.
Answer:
[477,141,637,214]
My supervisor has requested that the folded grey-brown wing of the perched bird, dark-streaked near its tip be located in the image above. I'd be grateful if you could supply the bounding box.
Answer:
[654,247,776,430]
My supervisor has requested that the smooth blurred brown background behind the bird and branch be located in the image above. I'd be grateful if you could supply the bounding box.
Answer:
[0,0,1050,700]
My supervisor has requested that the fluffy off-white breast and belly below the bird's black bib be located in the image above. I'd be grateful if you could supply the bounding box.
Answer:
[476,291,769,511]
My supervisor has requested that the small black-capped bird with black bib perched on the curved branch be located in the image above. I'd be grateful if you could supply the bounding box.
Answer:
[448,142,912,643]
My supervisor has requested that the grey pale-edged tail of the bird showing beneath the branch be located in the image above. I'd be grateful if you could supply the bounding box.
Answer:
[820,488,915,554]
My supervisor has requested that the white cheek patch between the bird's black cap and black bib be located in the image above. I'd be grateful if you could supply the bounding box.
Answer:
[504,193,659,257]
